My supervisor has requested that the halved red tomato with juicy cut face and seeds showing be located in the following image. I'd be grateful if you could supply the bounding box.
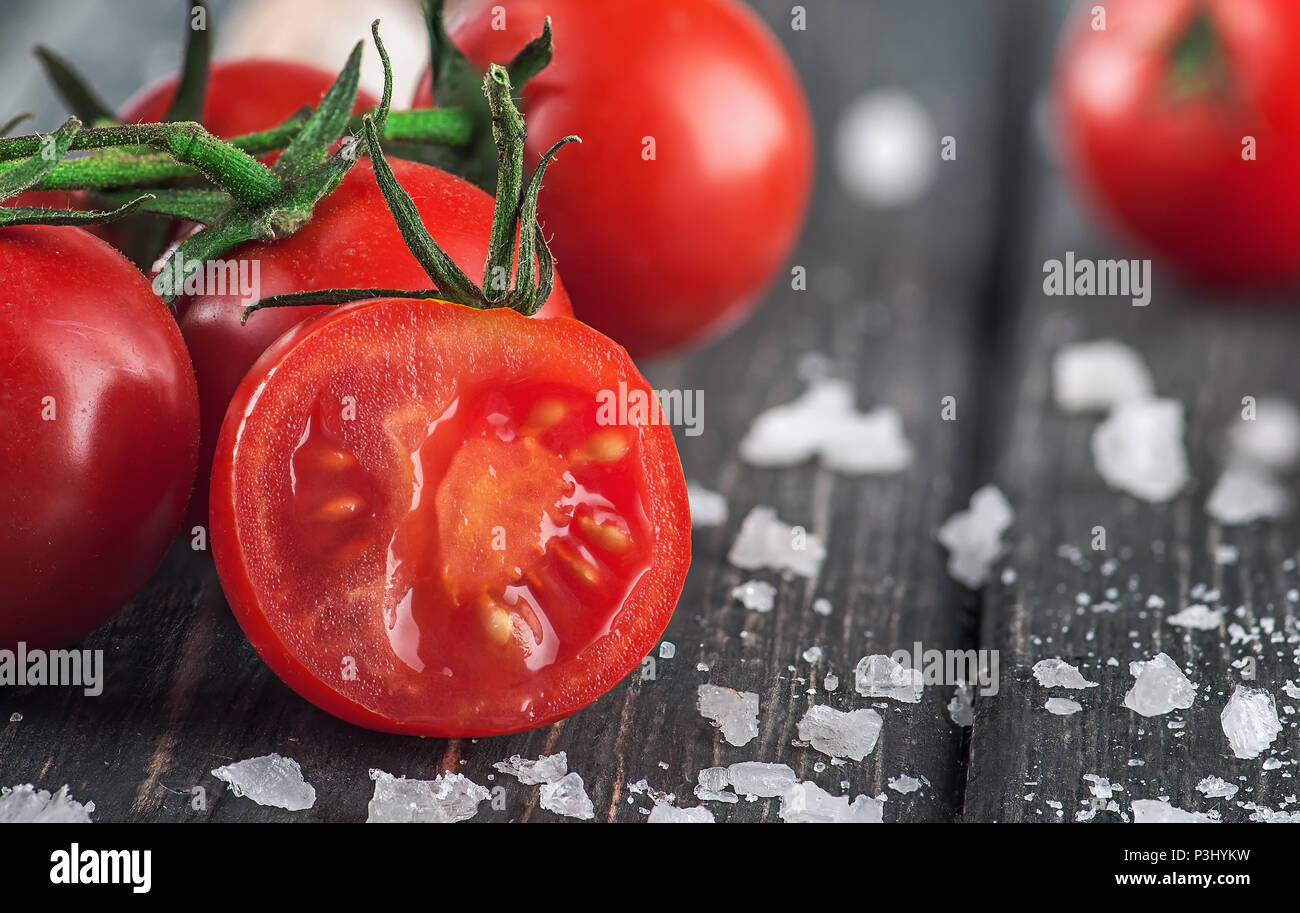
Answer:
[212,299,690,736]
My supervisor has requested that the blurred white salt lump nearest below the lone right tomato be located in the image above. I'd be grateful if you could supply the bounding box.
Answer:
[1052,339,1156,412]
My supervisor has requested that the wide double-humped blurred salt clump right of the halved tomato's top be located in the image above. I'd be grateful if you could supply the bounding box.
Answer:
[740,377,911,475]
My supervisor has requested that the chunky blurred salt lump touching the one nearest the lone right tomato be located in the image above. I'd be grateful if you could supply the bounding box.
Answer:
[1092,399,1190,502]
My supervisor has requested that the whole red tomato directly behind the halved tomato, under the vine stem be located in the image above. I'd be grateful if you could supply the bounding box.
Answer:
[178,159,572,524]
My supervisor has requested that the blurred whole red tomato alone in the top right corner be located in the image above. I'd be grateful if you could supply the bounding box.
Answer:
[1056,0,1300,286]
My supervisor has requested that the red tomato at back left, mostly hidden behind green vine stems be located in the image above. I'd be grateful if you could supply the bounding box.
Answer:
[122,57,378,139]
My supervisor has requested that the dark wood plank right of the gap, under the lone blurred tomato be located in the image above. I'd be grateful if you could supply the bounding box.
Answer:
[965,4,1300,821]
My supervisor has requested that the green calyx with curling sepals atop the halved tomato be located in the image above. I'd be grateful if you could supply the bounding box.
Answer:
[243,65,581,321]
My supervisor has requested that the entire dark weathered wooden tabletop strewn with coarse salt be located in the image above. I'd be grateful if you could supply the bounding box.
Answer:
[0,0,1300,822]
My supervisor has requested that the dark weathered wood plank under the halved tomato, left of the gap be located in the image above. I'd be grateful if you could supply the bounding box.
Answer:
[0,0,1001,821]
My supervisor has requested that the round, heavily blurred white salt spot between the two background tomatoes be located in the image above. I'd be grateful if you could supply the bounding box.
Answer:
[835,88,939,209]
